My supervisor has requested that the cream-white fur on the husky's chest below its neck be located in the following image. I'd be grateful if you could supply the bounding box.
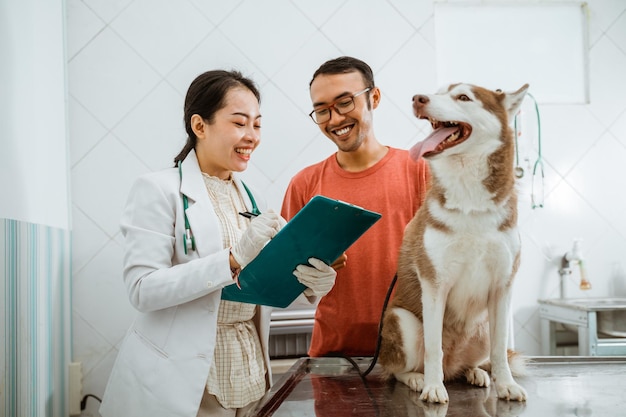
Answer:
[417,161,520,317]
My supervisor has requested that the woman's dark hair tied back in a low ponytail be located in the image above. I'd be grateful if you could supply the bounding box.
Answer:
[174,70,261,167]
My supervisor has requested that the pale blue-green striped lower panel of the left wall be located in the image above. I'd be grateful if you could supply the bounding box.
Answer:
[0,219,71,417]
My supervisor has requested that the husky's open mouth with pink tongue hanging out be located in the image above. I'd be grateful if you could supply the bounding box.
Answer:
[409,118,472,161]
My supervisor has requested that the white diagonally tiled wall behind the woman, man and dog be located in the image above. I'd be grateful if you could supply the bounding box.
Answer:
[67,0,626,415]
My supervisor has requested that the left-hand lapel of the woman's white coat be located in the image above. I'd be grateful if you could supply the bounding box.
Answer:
[180,150,223,257]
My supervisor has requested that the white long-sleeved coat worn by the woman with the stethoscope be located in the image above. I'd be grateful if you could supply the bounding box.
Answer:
[100,151,271,417]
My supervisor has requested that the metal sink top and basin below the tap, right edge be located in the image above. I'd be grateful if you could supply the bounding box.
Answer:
[539,297,626,338]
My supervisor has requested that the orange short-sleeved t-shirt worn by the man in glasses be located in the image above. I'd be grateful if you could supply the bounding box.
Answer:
[281,148,430,357]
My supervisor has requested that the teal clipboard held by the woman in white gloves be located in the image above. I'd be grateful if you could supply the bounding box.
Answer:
[222,195,381,308]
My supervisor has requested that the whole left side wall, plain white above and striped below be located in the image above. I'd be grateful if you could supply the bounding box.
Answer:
[0,0,71,417]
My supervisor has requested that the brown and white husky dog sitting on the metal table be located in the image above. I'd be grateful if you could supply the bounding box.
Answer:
[379,84,528,403]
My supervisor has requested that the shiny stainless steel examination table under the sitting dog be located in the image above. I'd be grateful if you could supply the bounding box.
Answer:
[250,357,626,417]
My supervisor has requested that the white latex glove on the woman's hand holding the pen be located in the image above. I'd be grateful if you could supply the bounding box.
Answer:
[230,210,286,268]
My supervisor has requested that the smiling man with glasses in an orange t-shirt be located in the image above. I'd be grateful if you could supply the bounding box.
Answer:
[281,56,430,356]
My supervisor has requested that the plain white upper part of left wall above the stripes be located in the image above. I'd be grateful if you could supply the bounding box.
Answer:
[0,0,70,229]
